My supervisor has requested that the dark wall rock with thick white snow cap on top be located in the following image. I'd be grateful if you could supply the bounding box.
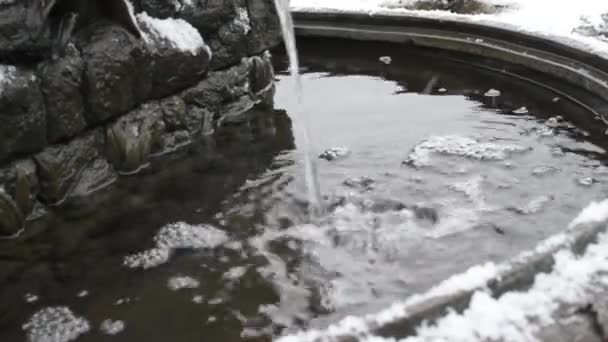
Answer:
[138,14,215,99]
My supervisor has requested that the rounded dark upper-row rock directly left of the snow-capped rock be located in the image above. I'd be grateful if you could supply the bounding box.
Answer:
[83,25,143,124]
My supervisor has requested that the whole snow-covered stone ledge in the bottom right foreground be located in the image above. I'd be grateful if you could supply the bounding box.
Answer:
[279,200,608,342]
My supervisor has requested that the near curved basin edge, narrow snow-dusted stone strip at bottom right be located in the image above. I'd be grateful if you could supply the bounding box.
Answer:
[279,212,608,342]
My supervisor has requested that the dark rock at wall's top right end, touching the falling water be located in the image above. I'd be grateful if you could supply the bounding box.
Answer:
[247,0,282,55]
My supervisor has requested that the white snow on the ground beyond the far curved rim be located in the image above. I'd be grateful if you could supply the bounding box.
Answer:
[291,0,608,59]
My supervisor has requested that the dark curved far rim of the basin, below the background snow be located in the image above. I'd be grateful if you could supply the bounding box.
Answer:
[293,11,608,122]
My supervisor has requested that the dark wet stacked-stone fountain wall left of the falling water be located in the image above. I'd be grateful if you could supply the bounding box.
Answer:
[0,0,280,236]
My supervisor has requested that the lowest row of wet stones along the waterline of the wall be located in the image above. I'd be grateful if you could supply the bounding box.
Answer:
[0,52,275,238]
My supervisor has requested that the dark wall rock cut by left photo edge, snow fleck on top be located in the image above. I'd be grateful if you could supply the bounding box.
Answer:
[0,65,46,163]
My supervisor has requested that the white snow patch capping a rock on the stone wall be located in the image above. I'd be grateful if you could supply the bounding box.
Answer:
[137,12,208,55]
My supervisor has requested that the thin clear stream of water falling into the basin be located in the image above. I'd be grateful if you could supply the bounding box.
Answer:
[274,0,325,221]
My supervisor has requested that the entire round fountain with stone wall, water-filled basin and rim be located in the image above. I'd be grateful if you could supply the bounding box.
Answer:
[0,0,608,342]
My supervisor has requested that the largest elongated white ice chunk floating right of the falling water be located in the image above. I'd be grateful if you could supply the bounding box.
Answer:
[403,135,530,167]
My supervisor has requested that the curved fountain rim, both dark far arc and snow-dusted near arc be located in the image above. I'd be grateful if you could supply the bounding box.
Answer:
[280,11,608,341]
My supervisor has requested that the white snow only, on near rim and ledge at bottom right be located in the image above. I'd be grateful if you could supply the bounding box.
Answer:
[278,199,608,342]
